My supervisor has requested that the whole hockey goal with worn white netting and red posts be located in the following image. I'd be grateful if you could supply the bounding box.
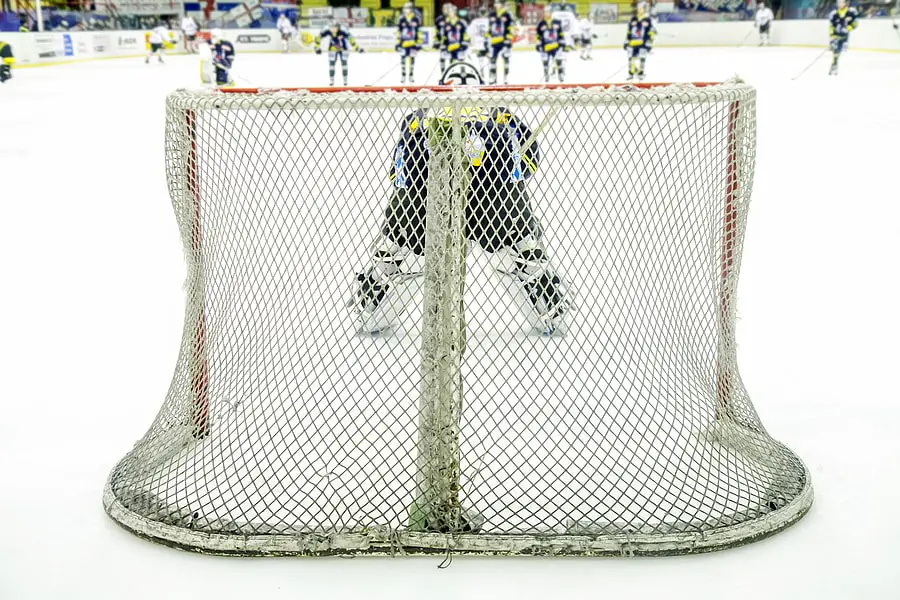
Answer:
[104,82,812,555]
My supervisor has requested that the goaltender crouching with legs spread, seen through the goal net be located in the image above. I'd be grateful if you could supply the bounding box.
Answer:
[349,63,570,335]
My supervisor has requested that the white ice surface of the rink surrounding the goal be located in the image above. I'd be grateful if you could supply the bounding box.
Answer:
[0,47,900,600]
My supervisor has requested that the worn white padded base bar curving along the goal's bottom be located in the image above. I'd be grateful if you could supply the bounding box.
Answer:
[103,478,813,557]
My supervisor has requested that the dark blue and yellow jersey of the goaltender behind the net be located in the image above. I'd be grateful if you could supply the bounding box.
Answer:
[390,107,540,190]
